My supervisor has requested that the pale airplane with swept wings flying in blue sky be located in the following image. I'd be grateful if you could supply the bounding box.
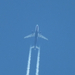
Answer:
[24,25,48,49]
